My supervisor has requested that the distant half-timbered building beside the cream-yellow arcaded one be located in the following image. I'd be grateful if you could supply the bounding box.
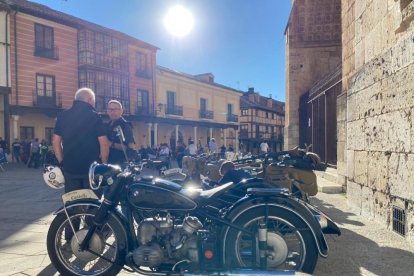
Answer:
[239,88,285,154]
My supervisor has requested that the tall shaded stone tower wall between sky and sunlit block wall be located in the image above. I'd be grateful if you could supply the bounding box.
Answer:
[285,0,342,153]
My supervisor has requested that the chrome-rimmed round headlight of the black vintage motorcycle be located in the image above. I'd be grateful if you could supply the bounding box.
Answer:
[88,162,122,190]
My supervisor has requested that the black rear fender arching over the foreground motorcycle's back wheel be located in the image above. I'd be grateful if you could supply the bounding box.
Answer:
[223,192,328,258]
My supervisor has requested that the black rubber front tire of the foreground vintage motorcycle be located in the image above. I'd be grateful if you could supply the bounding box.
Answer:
[47,208,127,276]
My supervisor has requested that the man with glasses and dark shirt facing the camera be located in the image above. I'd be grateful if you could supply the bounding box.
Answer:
[105,100,135,165]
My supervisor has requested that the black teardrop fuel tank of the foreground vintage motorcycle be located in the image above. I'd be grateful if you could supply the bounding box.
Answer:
[128,179,197,211]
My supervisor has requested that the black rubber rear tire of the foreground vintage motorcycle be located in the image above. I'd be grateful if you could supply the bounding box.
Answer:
[225,206,318,274]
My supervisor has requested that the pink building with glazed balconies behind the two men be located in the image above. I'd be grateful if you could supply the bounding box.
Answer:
[0,0,158,147]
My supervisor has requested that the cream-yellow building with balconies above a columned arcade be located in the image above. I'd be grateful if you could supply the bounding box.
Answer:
[150,66,242,153]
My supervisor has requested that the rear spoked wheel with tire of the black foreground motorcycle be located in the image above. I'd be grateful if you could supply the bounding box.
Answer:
[226,207,318,273]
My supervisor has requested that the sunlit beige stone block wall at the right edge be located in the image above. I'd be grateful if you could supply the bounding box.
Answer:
[342,0,414,243]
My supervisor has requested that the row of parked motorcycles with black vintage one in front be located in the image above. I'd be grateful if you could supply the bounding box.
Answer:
[43,130,340,275]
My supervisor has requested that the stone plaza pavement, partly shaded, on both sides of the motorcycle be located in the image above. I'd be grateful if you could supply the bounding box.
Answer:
[0,164,414,276]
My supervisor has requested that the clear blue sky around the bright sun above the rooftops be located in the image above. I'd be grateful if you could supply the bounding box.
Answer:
[32,0,291,101]
